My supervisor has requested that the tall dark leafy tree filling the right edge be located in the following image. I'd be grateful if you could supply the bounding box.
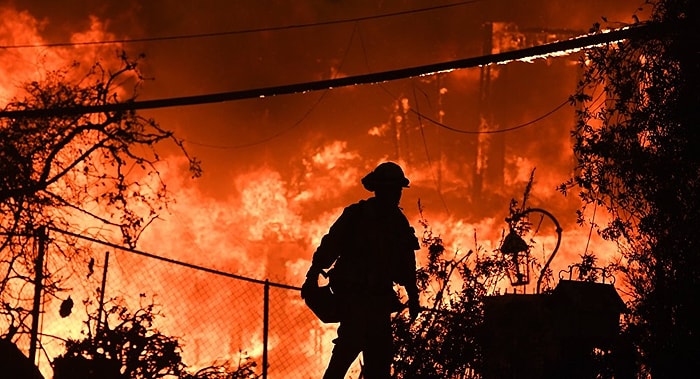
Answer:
[561,0,700,378]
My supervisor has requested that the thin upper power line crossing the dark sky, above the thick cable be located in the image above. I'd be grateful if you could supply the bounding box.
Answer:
[0,0,483,49]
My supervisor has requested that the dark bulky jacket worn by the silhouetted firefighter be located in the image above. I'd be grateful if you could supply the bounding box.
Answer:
[311,198,420,311]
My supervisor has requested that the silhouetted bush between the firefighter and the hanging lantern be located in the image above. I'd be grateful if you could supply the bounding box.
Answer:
[393,200,507,378]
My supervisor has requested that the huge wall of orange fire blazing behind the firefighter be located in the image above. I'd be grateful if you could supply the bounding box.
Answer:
[0,2,648,377]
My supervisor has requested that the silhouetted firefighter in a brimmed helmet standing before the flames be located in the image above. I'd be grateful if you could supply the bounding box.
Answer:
[302,162,420,379]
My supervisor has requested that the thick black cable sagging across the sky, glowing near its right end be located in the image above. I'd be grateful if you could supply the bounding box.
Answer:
[0,24,651,118]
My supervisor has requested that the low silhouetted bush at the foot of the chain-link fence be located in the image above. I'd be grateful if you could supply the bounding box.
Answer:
[53,302,259,379]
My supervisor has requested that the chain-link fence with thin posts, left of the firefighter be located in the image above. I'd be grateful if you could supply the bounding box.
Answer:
[4,230,366,379]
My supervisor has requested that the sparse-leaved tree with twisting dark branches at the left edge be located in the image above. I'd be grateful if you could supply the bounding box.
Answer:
[0,53,200,352]
